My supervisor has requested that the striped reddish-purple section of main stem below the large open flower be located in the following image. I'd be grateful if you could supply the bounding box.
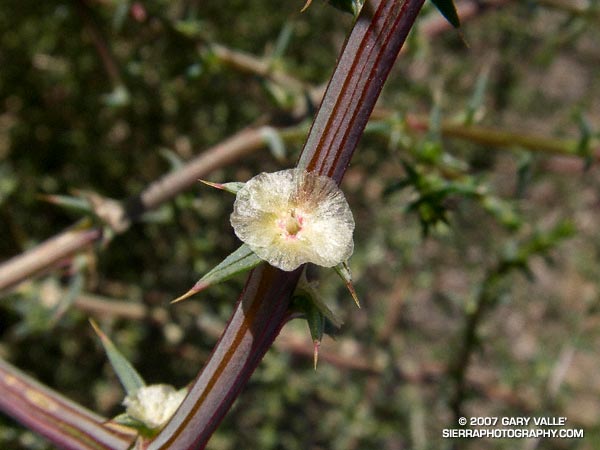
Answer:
[148,264,301,450]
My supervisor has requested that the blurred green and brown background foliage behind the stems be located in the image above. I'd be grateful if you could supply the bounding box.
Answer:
[0,0,600,450]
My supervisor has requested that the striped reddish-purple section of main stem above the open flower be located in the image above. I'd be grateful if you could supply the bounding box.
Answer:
[298,0,424,183]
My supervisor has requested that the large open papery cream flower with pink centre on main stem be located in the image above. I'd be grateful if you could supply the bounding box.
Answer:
[230,169,354,271]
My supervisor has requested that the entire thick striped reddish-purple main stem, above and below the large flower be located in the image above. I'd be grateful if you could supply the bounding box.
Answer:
[147,0,424,450]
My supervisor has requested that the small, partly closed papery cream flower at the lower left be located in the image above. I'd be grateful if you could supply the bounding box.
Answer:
[123,384,186,430]
